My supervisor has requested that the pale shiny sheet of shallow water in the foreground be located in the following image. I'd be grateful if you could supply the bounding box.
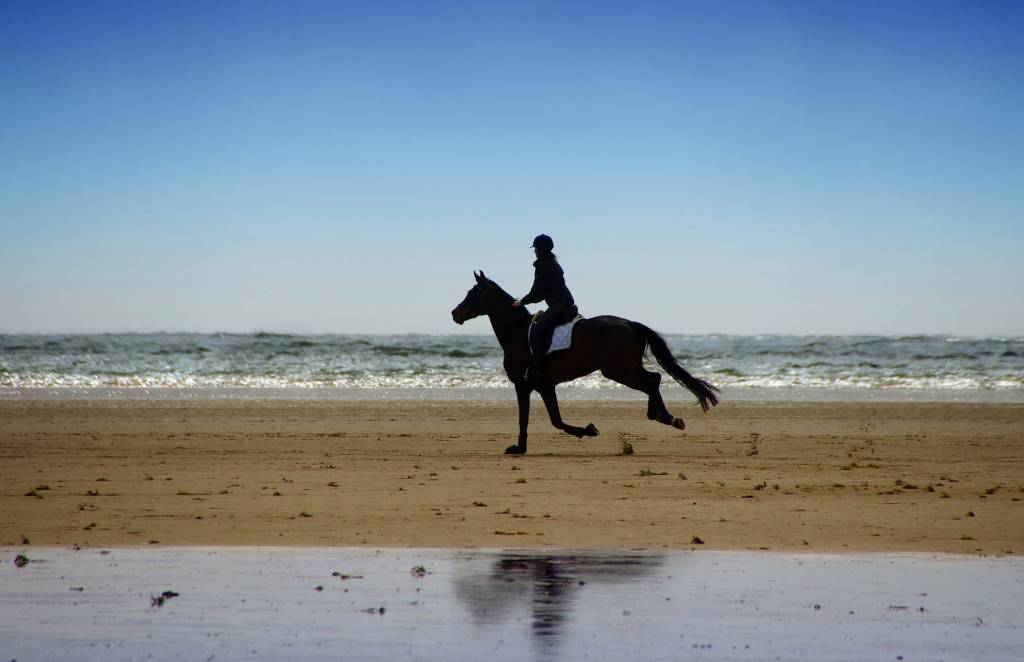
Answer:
[0,547,1024,662]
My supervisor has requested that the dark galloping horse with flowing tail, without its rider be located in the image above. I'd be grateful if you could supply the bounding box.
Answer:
[452,272,719,455]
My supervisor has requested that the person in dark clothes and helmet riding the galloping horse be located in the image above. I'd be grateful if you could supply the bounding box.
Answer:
[512,235,579,383]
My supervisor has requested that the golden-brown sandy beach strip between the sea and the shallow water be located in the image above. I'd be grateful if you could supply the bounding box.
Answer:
[0,399,1024,554]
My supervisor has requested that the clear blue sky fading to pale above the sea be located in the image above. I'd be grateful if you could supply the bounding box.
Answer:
[0,0,1024,335]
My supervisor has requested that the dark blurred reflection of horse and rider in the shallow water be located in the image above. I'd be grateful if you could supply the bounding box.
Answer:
[454,552,665,655]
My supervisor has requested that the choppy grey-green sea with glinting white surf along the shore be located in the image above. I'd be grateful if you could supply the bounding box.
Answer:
[0,333,1024,401]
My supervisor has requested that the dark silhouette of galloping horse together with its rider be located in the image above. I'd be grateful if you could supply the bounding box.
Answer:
[452,235,718,455]
